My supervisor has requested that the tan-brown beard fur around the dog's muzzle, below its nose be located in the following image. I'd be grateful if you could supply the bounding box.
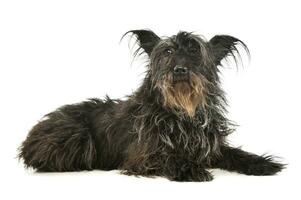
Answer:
[157,73,207,117]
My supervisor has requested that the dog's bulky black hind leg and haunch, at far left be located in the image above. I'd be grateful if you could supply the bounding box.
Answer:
[19,105,96,172]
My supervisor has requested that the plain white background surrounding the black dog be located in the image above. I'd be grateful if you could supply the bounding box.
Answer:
[0,0,301,199]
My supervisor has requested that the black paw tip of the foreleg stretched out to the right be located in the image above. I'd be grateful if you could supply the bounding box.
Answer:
[246,156,285,176]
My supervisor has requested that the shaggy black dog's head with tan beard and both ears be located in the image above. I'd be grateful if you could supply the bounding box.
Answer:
[126,30,248,117]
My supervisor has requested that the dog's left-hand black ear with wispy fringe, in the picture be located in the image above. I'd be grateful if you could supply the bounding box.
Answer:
[123,29,160,56]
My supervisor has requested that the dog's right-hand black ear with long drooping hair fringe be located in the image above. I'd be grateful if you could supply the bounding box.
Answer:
[209,35,250,65]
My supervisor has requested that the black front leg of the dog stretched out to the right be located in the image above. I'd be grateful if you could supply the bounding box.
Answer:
[211,146,284,176]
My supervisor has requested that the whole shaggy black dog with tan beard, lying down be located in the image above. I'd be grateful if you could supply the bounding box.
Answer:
[19,30,284,181]
